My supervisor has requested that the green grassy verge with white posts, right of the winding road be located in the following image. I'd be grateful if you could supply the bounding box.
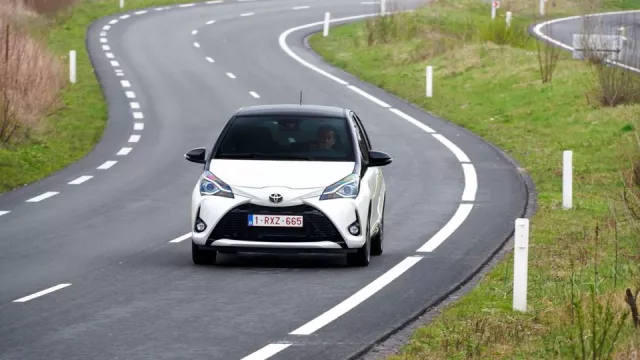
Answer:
[310,0,640,360]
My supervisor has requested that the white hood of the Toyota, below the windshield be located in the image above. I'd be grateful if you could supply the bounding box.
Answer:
[209,159,355,189]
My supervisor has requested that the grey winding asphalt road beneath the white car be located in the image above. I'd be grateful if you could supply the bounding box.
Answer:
[0,0,527,360]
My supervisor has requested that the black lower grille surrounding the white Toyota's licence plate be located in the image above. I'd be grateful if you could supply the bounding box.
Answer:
[209,204,344,243]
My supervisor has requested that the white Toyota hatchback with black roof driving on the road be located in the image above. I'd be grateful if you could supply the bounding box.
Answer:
[185,105,392,266]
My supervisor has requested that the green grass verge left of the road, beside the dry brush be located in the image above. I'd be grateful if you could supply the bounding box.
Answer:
[0,0,204,193]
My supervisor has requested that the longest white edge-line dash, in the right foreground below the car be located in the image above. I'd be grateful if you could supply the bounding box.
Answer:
[289,256,422,335]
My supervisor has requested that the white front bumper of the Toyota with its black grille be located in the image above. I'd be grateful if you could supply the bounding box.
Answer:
[192,196,368,253]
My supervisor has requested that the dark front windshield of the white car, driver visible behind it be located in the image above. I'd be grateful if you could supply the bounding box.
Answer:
[214,116,354,161]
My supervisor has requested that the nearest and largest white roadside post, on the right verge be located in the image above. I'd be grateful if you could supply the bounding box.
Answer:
[513,218,529,311]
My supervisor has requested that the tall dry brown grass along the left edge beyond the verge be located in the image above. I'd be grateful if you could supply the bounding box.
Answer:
[0,2,65,146]
